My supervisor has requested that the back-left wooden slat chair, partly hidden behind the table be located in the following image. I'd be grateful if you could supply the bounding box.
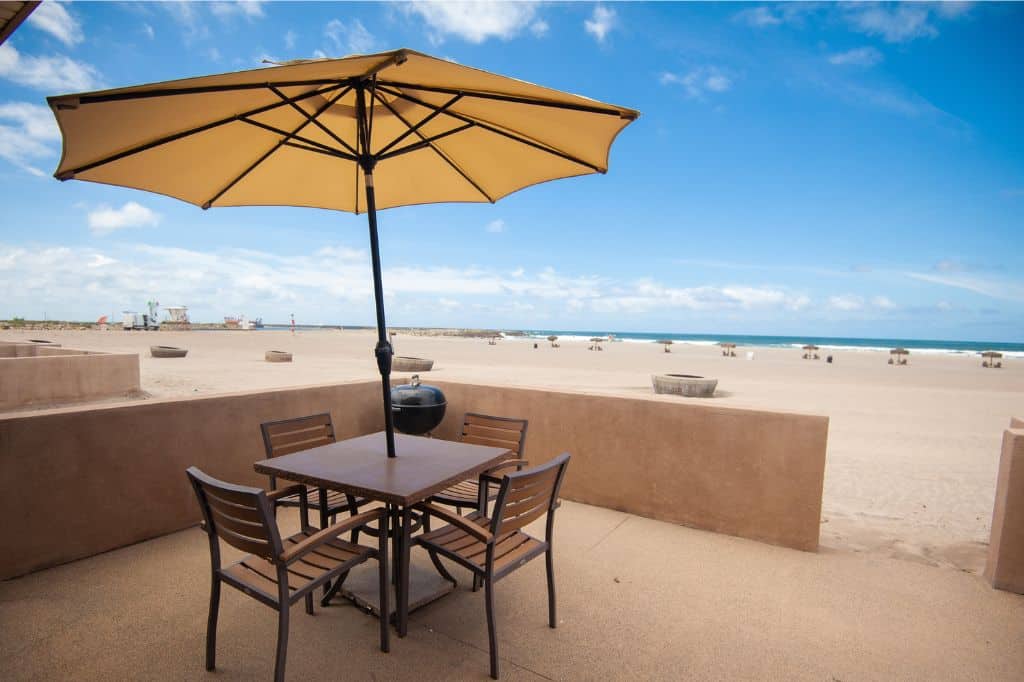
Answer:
[259,413,367,528]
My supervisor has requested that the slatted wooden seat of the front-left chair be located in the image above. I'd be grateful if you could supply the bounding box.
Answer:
[220,528,374,604]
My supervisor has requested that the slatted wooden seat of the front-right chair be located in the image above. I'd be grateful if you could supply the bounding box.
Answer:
[417,512,548,577]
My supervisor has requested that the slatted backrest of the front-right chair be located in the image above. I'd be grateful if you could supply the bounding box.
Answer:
[490,453,569,536]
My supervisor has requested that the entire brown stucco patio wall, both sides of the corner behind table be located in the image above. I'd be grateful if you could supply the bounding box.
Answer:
[0,382,827,579]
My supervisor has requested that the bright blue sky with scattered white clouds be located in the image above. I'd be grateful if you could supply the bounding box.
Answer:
[0,2,1024,341]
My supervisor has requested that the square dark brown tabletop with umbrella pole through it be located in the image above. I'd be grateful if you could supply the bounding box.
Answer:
[255,431,515,506]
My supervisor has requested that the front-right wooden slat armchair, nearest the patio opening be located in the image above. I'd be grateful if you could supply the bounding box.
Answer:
[416,453,569,680]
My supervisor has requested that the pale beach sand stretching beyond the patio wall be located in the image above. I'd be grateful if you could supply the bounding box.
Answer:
[0,331,1024,573]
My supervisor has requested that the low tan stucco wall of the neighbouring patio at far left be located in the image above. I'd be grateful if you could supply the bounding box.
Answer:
[0,344,140,411]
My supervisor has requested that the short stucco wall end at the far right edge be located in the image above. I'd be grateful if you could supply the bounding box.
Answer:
[985,419,1024,594]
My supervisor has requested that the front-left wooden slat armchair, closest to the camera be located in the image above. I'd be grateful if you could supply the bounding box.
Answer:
[186,467,389,682]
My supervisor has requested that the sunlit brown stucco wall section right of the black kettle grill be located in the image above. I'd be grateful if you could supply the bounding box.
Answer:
[432,382,828,551]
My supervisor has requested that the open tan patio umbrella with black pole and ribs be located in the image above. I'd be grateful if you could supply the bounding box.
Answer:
[48,49,638,450]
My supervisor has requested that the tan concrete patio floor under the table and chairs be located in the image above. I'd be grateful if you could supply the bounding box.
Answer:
[0,502,1024,682]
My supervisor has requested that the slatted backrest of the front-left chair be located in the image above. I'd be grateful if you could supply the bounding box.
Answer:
[185,467,283,563]
